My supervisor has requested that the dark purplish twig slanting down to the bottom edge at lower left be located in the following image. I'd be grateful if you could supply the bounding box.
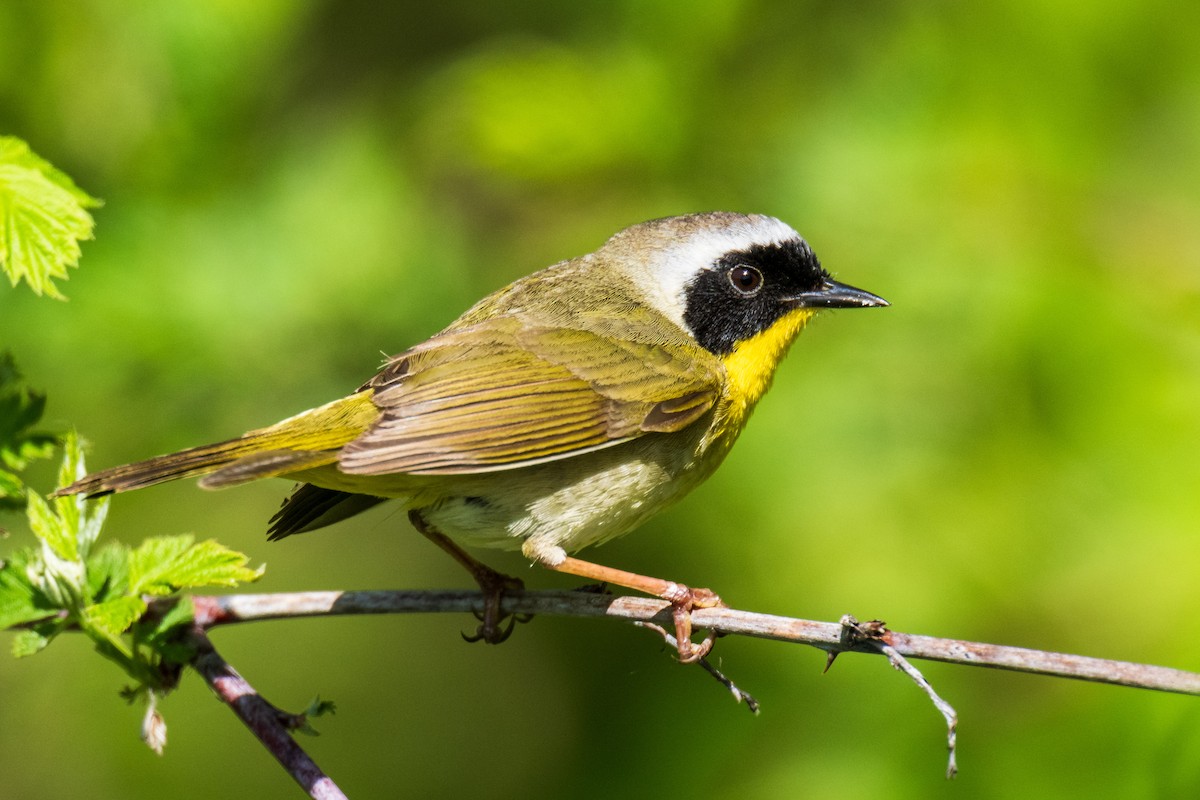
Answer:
[188,626,346,800]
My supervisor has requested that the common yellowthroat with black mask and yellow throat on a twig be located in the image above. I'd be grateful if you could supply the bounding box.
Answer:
[59,212,888,661]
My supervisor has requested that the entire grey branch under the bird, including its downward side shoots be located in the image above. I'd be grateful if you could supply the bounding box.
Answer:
[170,590,1200,786]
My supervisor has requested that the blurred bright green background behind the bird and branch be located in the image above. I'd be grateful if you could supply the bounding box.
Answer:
[0,0,1200,800]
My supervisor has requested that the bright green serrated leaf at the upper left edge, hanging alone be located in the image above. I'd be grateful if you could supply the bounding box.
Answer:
[0,137,101,299]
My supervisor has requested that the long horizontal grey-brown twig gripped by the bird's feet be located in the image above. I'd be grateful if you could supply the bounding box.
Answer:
[184,590,1200,694]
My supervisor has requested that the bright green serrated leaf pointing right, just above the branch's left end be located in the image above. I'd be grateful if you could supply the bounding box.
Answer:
[130,535,263,595]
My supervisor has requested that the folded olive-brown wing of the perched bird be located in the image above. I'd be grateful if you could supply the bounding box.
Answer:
[338,317,722,475]
